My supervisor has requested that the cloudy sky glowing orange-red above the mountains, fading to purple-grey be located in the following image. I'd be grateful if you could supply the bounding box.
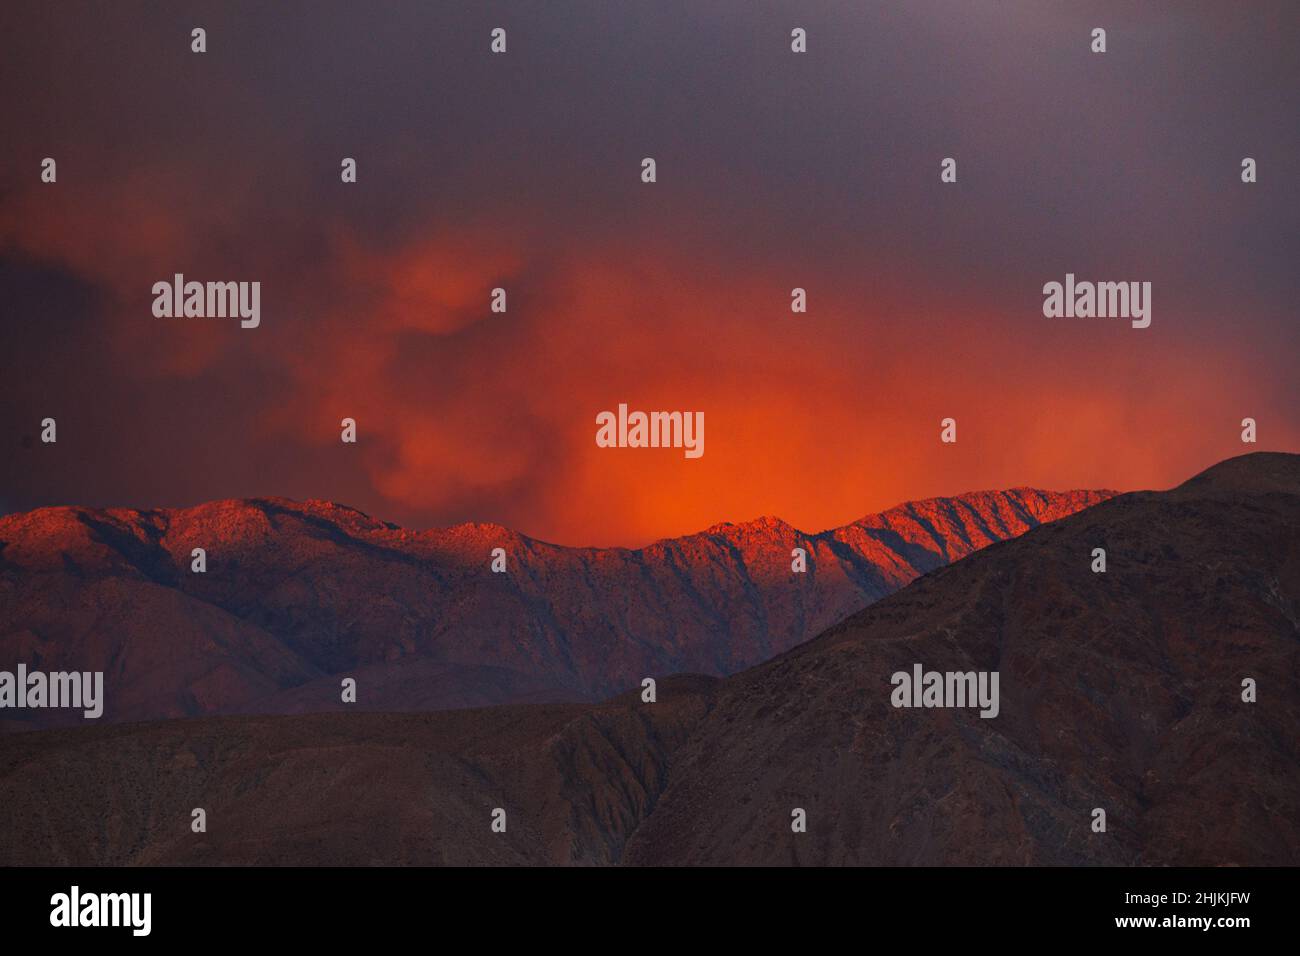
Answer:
[0,0,1300,546]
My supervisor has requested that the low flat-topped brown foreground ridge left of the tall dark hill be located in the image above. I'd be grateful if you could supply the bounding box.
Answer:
[0,678,714,866]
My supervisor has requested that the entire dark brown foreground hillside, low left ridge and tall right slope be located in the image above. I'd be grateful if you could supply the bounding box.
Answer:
[0,454,1300,865]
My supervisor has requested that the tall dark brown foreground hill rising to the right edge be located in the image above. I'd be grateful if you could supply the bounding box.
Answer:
[627,454,1300,865]
